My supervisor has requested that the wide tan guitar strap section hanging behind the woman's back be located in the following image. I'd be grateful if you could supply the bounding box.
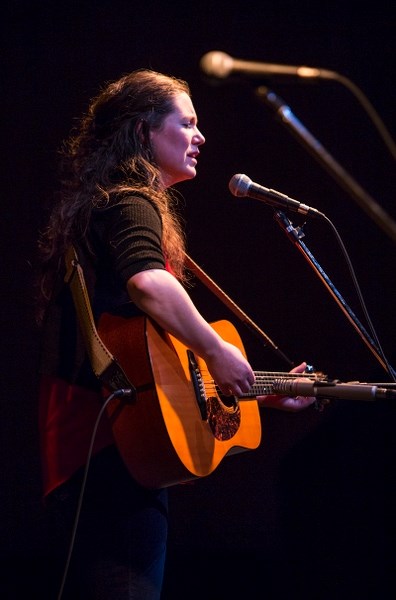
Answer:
[64,246,135,391]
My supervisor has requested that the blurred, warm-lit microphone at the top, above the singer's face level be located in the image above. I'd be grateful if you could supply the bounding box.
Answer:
[199,51,334,79]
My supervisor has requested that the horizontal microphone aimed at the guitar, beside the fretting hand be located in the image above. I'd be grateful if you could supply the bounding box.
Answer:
[272,379,396,400]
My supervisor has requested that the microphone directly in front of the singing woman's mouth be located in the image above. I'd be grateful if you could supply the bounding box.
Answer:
[228,173,324,217]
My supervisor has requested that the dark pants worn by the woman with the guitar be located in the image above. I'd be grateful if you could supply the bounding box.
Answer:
[47,448,168,600]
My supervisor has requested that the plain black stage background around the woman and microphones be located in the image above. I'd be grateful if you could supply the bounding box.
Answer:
[0,0,396,600]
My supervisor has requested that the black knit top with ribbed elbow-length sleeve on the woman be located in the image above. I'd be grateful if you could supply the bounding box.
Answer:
[40,196,166,389]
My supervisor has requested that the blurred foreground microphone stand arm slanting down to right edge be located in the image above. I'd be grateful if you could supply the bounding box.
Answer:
[256,86,396,242]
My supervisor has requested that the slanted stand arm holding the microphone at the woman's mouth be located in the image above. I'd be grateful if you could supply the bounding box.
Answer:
[274,211,396,381]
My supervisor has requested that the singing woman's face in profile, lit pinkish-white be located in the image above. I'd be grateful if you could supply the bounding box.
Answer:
[150,92,205,187]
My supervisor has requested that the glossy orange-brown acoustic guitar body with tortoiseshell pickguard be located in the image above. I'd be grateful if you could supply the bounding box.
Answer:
[98,314,261,488]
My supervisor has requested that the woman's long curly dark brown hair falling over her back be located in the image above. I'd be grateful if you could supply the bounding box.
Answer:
[38,69,191,321]
